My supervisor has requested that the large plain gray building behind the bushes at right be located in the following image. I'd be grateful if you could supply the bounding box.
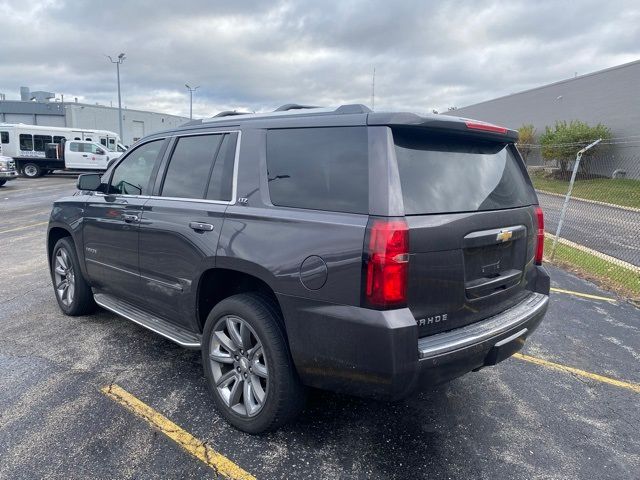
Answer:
[446,60,640,177]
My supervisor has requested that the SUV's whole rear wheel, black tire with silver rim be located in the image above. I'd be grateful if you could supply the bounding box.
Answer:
[202,293,304,434]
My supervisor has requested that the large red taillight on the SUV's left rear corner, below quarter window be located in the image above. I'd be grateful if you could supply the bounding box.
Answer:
[363,218,409,309]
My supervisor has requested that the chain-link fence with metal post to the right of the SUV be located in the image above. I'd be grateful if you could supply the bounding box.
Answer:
[528,151,640,300]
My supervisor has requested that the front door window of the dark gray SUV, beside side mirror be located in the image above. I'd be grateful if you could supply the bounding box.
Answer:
[109,140,164,195]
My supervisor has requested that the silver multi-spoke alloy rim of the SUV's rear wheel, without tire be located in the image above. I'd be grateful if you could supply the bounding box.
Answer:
[209,315,269,417]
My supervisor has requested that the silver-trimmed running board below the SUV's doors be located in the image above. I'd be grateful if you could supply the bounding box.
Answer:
[93,293,202,348]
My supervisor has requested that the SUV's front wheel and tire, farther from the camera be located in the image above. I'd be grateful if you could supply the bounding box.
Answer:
[50,237,95,317]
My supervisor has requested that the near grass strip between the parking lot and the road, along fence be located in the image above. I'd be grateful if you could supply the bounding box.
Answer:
[544,242,640,303]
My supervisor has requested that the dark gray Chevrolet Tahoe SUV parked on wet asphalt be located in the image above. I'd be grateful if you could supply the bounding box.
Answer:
[47,105,549,433]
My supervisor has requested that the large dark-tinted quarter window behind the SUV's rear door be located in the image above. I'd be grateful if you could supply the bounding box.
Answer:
[267,127,369,213]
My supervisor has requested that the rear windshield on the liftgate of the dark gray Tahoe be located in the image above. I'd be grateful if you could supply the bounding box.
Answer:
[393,129,536,215]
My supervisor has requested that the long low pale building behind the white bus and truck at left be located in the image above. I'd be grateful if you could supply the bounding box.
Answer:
[0,87,189,145]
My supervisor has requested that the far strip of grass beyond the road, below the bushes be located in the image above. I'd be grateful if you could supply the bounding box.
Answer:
[531,172,640,208]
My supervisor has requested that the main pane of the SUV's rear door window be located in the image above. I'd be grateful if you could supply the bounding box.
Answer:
[162,134,223,198]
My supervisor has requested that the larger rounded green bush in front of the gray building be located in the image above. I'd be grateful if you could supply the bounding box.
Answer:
[540,120,611,178]
